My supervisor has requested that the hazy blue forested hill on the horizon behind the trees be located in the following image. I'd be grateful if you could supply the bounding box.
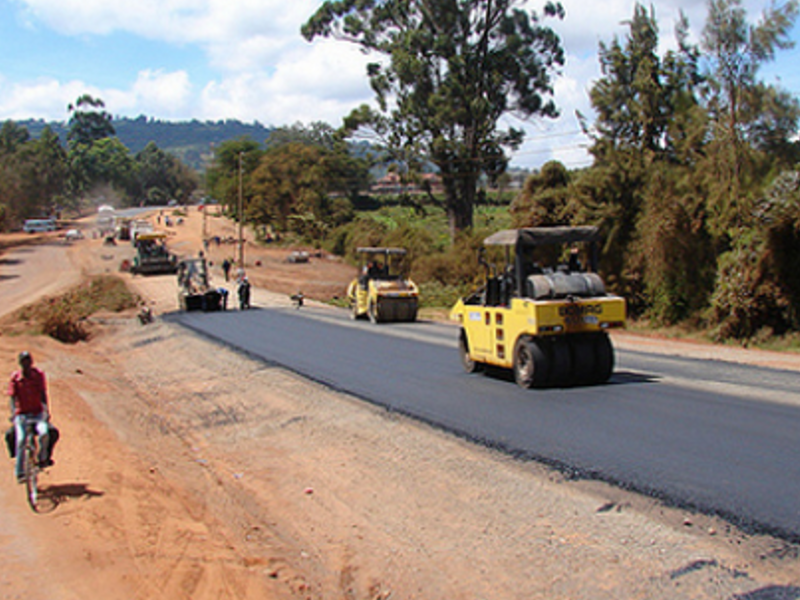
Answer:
[17,116,272,170]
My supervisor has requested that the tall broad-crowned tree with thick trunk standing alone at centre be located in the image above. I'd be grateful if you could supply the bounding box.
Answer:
[302,0,564,235]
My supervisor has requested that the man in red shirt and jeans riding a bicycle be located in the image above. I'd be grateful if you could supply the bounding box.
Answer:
[8,351,55,482]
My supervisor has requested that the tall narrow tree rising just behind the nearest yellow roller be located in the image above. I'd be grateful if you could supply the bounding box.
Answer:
[573,5,713,322]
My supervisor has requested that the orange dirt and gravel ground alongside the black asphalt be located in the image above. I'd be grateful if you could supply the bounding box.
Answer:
[0,216,800,600]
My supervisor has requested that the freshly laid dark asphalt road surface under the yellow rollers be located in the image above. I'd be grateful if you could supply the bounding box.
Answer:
[177,308,800,540]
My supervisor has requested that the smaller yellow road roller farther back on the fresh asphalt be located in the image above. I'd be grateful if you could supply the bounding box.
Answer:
[347,247,419,323]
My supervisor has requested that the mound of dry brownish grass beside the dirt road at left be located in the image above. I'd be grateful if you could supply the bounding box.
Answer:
[12,275,140,344]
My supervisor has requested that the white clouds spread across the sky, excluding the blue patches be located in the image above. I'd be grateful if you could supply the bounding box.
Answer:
[6,0,796,166]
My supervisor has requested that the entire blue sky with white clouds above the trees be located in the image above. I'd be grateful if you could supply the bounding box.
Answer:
[0,0,800,167]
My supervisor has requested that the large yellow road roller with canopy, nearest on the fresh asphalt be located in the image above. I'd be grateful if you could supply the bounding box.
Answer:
[450,227,626,388]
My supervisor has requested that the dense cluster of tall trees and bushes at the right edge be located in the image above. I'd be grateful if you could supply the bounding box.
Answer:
[512,0,800,338]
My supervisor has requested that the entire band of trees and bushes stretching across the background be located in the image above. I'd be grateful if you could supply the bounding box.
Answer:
[0,0,800,346]
